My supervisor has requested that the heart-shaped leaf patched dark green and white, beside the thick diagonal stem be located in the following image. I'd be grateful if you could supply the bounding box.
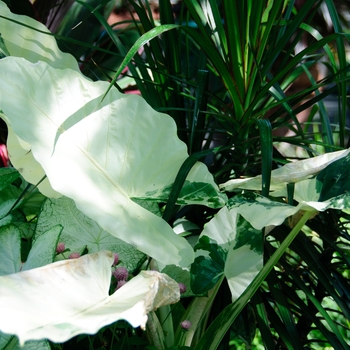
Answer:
[191,206,264,300]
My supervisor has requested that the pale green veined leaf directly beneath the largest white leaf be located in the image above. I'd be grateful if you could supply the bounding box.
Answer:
[35,197,144,271]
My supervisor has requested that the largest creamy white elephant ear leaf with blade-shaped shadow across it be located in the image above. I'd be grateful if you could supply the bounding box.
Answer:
[0,57,222,266]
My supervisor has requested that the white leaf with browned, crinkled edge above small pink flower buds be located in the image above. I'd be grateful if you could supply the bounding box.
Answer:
[0,251,180,345]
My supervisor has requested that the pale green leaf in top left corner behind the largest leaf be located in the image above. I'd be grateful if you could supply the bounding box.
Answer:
[0,1,79,71]
